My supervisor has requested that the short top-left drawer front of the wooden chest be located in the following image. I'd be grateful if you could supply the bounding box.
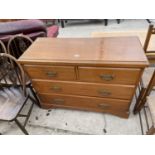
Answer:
[24,65,76,80]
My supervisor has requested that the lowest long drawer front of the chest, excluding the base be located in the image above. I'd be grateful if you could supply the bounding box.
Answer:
[39,94,130,111]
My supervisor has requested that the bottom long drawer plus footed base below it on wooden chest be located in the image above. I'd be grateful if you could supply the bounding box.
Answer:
[39,94,130,118]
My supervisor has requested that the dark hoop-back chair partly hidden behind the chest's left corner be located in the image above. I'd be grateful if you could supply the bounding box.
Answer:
[7,35,40,106]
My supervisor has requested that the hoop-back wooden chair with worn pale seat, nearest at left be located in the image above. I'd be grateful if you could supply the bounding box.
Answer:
[0,53,36,135]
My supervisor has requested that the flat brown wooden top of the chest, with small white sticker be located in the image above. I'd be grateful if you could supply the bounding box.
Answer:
[19,37,148,66]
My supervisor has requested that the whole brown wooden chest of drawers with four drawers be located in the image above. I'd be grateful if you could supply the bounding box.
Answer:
[19,37,148,118]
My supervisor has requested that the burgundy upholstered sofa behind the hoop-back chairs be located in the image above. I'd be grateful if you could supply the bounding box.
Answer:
[0,19,59,44]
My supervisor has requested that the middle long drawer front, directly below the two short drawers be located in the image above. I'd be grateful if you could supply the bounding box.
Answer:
[32,80,134,99]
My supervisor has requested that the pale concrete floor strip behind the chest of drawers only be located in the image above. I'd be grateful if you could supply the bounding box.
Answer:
[59,19,148,38]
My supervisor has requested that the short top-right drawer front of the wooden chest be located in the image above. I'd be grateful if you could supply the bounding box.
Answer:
[78,67,141,85]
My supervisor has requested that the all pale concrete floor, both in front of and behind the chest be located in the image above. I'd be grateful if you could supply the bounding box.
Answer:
[0,20,151,135]
